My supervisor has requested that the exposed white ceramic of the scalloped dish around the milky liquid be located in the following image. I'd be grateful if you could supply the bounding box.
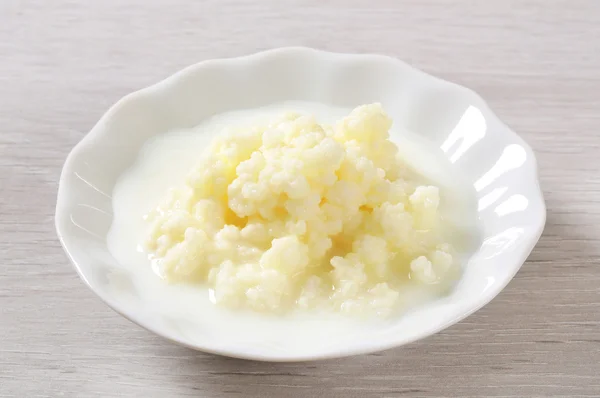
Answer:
[56,48,546,361]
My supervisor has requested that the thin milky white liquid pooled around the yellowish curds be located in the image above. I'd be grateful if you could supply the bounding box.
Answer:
[107,102,477,348]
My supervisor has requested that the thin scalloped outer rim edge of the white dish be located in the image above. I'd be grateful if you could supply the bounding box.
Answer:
[55,47,546,362]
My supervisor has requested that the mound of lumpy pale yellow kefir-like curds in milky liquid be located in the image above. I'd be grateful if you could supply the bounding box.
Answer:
[143,104,459,316]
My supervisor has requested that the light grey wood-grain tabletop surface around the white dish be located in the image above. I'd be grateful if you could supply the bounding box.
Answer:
[0,0,600,397]
